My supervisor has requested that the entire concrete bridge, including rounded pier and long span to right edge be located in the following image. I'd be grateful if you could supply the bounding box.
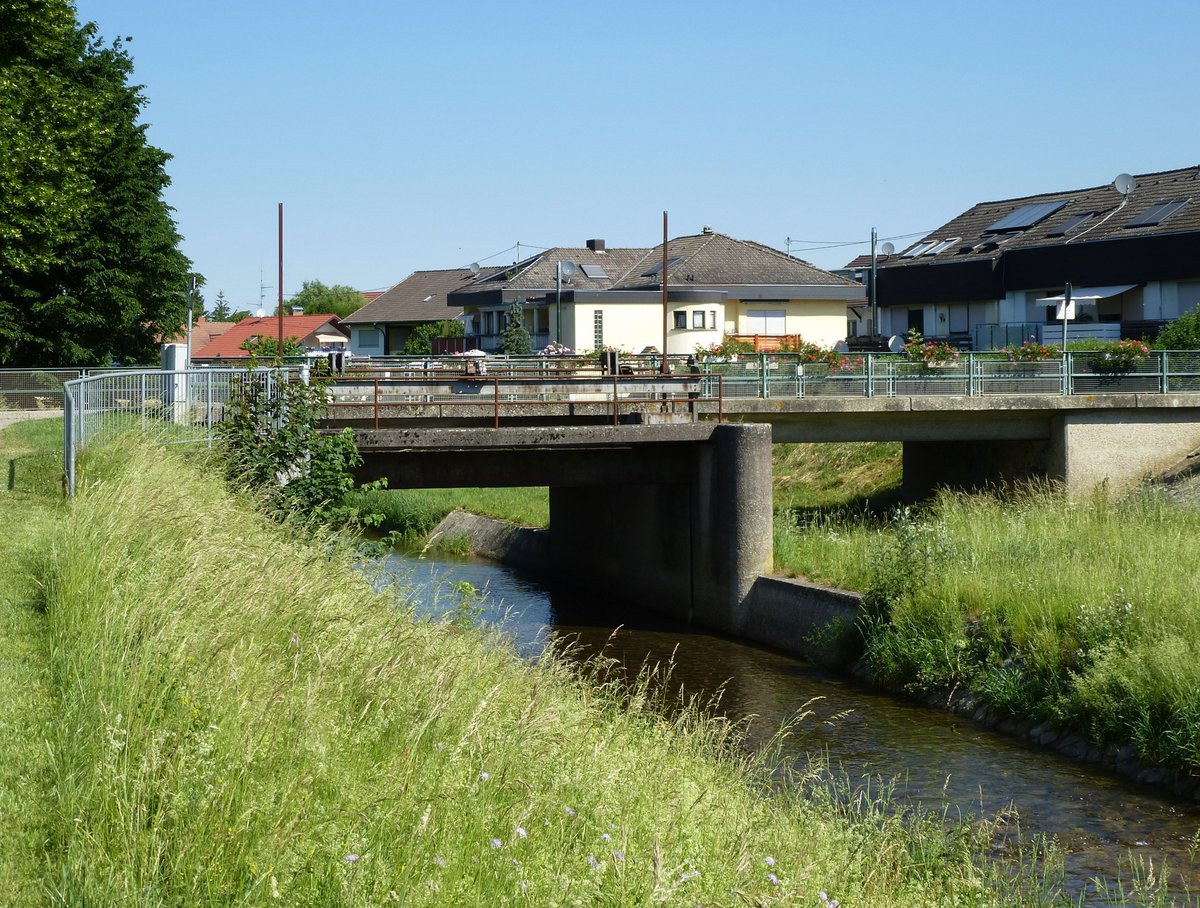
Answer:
[330,378,1200,635]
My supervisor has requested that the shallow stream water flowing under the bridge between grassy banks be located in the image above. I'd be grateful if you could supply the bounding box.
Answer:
[388,555,1200,904]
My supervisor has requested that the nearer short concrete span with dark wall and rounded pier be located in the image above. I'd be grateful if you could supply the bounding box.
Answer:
[355,422,772,635]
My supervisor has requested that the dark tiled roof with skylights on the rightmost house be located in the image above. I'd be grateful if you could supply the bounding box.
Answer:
[887,167,1200,267]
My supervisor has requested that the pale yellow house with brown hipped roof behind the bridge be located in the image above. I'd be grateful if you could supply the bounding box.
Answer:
[448,228,864,355]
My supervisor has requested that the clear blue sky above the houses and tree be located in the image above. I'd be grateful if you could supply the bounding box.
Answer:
[77,0,1200,309]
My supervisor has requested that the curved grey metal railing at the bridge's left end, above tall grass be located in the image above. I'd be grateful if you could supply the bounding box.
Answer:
[61,368,292,495]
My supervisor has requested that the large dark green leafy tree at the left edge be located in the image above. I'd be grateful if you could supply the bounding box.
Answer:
[0,0,190,366]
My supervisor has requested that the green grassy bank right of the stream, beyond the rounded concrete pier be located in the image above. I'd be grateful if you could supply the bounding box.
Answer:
[367,445,1200,772]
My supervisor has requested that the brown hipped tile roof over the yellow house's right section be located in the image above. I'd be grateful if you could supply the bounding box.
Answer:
[616,233,854,290]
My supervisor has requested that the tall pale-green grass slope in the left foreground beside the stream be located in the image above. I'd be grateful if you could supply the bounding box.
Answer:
[0,427,1070,907]
